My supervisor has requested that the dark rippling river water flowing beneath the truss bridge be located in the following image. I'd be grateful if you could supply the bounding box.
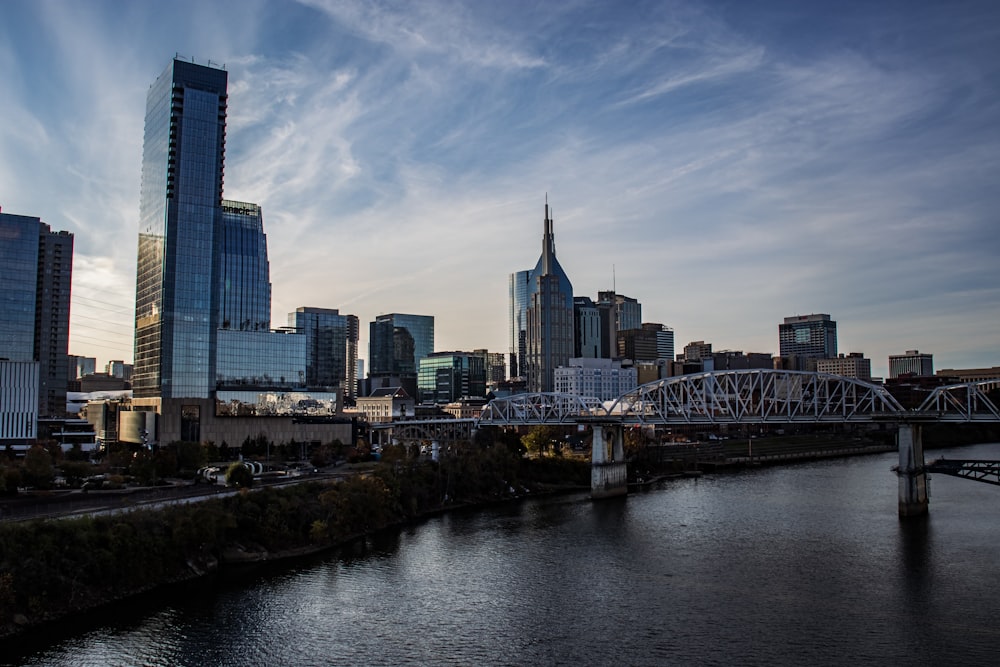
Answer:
[7,444,1000,667]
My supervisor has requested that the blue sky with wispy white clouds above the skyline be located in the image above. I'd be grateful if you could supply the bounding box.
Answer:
[0,0,1000,376]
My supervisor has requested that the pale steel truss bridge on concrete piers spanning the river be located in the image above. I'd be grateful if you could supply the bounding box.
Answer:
[372,369,1000,517]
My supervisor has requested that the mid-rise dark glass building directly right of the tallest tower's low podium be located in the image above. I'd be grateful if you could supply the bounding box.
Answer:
[288,306,359,398]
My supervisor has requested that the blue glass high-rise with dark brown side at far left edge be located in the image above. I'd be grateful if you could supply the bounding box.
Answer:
[0,212,73,426]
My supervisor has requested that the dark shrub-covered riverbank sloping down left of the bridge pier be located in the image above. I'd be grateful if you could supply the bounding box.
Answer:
[0,448,589,641]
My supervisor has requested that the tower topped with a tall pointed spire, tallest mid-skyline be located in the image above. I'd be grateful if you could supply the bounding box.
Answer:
[525,196,573,392]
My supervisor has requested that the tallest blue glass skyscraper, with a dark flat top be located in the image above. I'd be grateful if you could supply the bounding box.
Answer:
[132,58,227,398]
